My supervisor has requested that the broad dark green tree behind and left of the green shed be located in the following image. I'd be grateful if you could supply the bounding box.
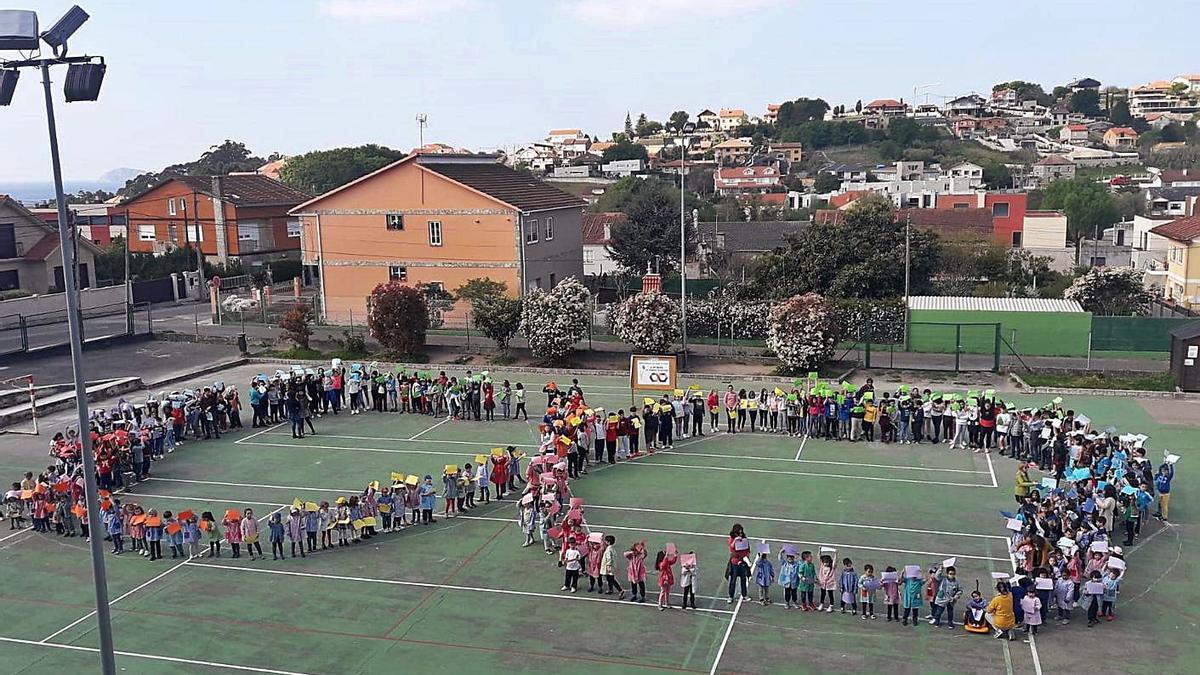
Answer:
[751,196,941,298]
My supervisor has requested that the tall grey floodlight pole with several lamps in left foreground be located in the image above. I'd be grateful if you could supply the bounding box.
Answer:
[0,5,116,675]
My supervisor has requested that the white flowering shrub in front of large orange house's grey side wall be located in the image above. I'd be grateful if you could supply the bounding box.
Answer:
[521,276,592,363]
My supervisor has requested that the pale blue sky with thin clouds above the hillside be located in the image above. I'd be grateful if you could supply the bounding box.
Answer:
[0,0,1200,183]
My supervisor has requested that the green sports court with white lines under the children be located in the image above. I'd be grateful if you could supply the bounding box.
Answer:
[0,369,1200,674]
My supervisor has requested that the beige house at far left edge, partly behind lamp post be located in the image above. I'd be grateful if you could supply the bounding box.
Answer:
[0,195,101,294]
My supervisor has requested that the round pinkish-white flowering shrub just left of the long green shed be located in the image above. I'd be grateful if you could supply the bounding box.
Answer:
[767,293,836,372]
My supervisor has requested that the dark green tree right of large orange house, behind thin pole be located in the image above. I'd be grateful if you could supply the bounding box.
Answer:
[608,180,696,274]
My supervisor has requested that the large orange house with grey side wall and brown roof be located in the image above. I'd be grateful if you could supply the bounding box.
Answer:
[290,154,586,323]
